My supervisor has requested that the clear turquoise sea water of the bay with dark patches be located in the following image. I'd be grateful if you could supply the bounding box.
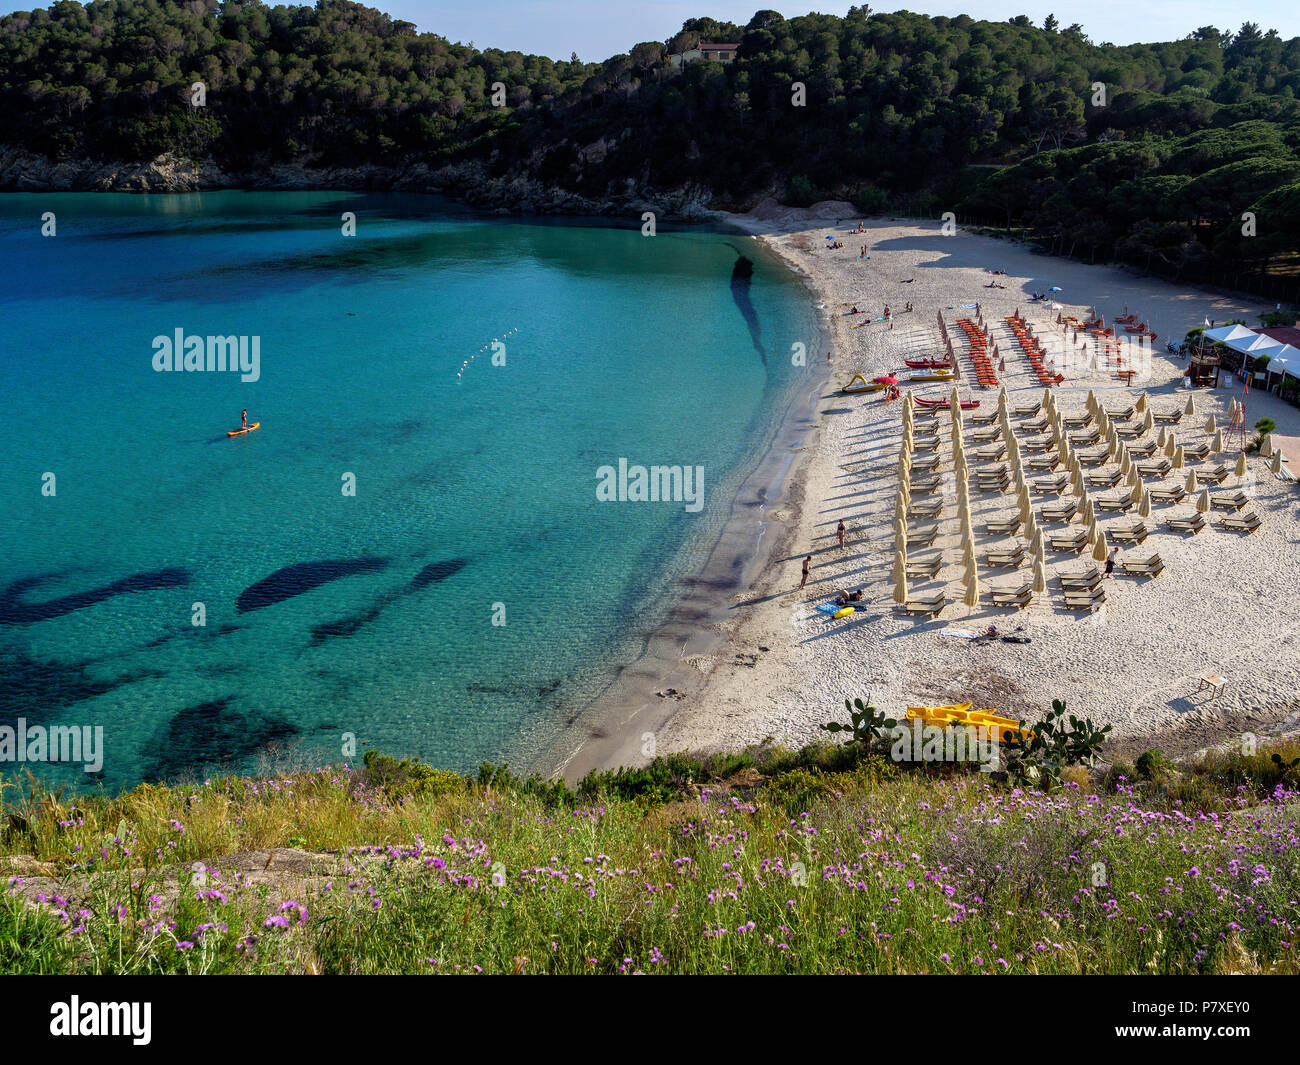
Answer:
[0,192,816,787]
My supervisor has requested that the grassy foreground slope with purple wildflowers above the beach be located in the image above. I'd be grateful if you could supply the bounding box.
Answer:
[0,741,1300,974]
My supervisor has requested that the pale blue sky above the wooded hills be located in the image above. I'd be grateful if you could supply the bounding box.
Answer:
[374,0,1300,61]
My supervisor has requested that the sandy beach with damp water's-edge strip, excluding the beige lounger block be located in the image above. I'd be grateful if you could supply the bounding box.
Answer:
[560,203,1300,780]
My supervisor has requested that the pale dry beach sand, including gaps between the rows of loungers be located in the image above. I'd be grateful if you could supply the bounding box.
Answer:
[660,203,1300,750]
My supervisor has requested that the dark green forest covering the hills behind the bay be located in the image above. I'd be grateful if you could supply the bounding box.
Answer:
[0,0,1300,291]
